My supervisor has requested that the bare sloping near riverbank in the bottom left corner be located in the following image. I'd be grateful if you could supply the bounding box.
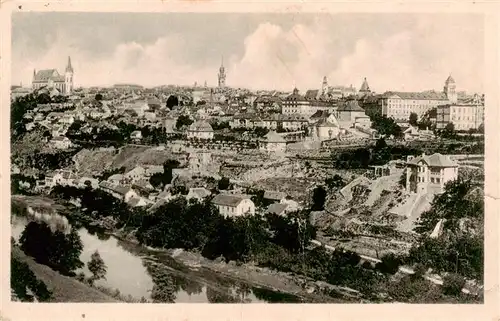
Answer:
[11,247,121,303]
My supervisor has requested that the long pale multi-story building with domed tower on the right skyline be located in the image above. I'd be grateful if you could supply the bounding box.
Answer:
[380,76,457,120]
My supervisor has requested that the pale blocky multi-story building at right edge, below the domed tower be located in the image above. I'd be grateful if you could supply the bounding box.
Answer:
[436,95,484,130]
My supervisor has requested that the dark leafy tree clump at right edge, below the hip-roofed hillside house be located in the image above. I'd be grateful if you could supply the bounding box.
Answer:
[408,179,484,280]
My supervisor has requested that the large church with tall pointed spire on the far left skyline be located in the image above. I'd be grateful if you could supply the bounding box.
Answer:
[32,57,74,95]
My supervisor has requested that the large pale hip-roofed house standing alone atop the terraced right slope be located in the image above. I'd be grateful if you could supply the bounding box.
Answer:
[406,153,458,194]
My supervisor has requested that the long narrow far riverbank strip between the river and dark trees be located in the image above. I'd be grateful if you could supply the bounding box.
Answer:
[13,196,360,303]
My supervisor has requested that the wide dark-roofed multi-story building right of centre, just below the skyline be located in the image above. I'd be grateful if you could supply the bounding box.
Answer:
[281,88,335,117]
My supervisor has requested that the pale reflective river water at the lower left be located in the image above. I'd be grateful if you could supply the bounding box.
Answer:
[11,215,300,303]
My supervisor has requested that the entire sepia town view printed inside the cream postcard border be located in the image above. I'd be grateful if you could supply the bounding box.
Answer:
[2,2,498,320]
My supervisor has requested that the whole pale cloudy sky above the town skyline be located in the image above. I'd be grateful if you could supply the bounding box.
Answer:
[12,12,484,93]
